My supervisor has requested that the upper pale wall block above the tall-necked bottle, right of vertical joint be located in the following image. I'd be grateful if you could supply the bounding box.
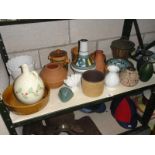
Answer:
[70,19,124,42]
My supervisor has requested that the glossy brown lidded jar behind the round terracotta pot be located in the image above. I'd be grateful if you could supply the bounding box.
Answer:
[48,49,69,69]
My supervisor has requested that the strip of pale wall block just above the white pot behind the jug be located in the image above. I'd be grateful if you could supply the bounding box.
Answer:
[8,50,41,69]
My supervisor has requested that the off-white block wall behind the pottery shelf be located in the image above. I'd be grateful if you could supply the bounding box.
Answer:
[0,19,155,134]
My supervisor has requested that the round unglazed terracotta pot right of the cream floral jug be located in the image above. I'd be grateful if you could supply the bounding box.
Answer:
[40,63,67,88]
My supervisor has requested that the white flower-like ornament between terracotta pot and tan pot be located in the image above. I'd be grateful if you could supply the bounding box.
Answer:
[64,74,81,92]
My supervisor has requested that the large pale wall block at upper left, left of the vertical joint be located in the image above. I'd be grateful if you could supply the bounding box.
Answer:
[0,20,69,52]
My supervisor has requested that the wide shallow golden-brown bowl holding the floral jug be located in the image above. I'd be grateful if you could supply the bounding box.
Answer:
[2,85,50,115]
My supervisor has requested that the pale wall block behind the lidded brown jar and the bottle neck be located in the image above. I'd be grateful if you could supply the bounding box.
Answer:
[39,41,96,67]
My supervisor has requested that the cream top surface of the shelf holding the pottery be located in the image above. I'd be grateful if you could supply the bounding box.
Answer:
[10,75,155,126]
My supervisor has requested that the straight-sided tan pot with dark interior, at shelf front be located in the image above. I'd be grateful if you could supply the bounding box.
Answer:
[81,70,104,97]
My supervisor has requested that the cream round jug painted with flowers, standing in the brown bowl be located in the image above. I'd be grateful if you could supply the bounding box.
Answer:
[14,64,45,104]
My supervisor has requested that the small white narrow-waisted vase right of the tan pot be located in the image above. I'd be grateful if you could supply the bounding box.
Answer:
[105,65,120,87]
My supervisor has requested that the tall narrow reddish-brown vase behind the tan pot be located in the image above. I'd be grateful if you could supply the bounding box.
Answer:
[95,50,107,73]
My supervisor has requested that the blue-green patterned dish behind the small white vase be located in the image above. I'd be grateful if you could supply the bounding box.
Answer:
[107,58,134,71]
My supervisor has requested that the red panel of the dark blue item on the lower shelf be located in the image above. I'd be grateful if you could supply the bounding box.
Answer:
[114,98,131,123]
